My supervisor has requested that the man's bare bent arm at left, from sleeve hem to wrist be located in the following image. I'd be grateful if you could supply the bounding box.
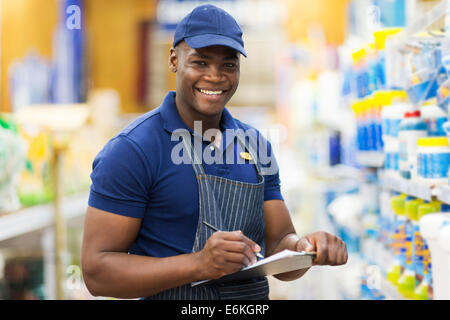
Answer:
[82,207,204,298]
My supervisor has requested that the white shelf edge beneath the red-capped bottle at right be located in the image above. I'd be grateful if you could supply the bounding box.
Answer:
[382,175,440,202]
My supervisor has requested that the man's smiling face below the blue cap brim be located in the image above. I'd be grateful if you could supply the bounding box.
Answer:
[169,41,240,127]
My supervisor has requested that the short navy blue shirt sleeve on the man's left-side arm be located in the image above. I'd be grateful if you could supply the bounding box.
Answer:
[88,135,151,218]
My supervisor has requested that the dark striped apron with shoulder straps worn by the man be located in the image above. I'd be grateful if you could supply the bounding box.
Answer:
[146,134,269,300]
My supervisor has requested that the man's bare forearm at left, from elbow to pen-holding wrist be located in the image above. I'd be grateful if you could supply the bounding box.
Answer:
[83,252,201,299]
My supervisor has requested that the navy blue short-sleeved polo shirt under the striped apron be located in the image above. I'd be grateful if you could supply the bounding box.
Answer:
[88,91,283,257]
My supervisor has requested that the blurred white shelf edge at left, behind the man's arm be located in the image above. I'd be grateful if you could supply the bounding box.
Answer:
[0,192,88,241]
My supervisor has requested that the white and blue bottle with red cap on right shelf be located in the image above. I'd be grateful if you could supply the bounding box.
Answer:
[398,110,427,179]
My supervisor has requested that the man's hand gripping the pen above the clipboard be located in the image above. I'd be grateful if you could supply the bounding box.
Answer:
[197,231,261,280]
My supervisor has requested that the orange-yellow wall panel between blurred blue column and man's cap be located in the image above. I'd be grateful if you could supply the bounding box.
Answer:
[86,0,156,112]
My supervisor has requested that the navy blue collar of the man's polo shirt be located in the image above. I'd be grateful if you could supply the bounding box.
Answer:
[160,91,238,133]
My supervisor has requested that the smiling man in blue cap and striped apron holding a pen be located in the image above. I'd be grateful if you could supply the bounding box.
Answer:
[82,5,347,299]
